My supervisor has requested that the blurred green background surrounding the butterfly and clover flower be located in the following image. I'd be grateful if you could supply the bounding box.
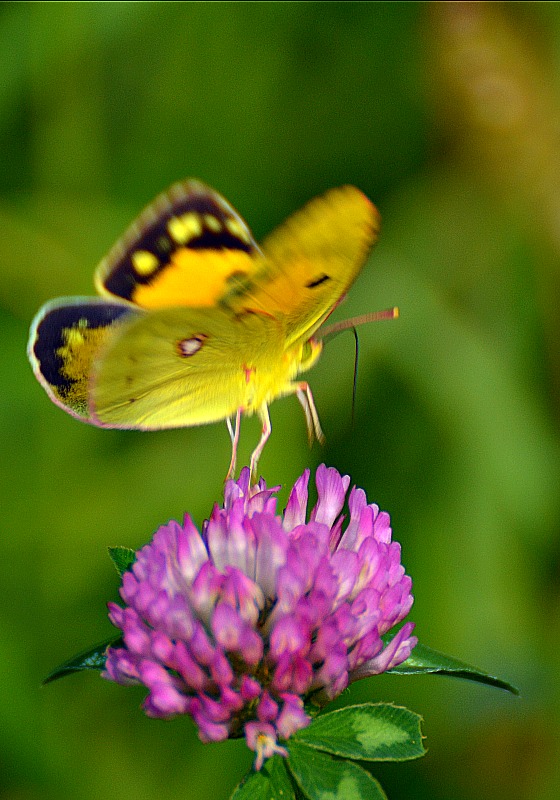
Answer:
[0,2,560,800]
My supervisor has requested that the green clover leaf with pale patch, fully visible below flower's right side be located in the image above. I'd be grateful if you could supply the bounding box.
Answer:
[293,703,426,761]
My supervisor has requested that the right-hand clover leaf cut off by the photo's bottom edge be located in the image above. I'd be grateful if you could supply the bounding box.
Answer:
[287,739,387,800]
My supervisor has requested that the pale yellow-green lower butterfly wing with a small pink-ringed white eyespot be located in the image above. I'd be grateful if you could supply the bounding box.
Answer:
[90,308,262,430]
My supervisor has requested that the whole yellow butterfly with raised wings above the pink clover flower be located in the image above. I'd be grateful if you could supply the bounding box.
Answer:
[28,180,396,479]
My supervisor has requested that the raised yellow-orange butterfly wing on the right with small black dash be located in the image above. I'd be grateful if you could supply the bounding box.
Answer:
[224,186,380,347]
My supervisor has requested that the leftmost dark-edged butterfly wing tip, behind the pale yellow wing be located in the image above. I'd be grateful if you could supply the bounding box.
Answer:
[27,297,137,422]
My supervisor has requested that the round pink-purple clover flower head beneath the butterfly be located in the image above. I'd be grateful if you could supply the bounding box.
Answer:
[103,465,416,768]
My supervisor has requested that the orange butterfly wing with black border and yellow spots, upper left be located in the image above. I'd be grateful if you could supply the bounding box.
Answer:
[95,180,262,309]
